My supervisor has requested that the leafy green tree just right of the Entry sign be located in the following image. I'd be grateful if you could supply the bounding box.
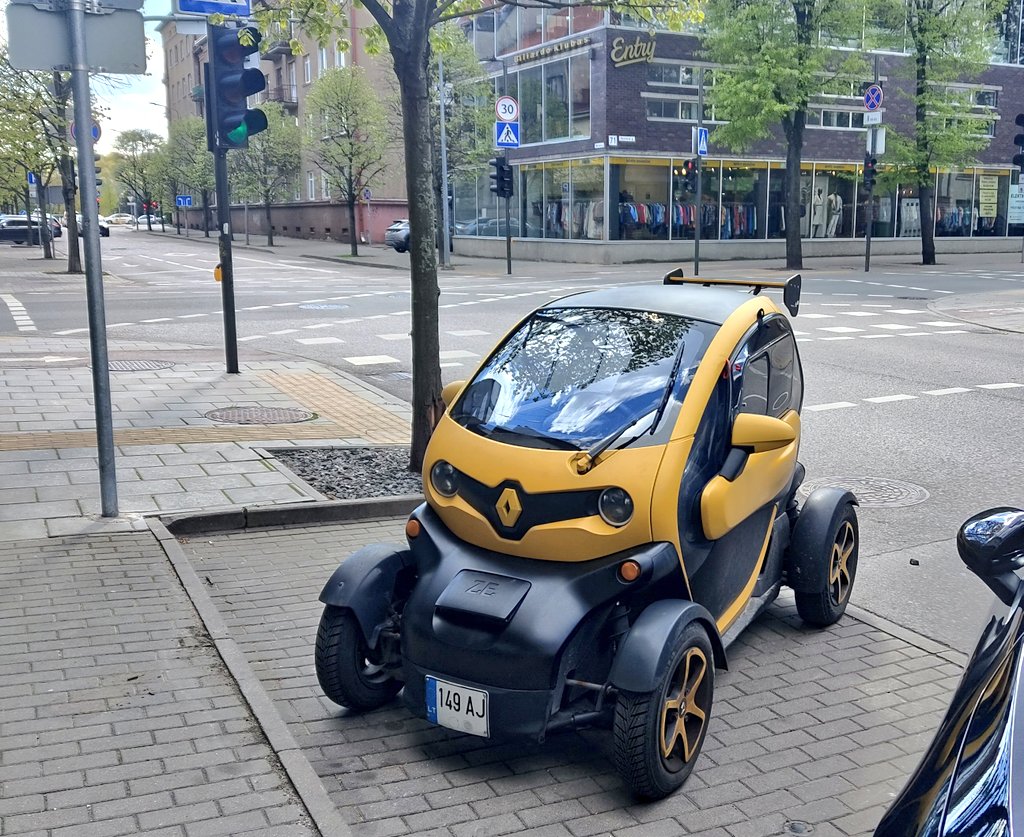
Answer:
[703,0,863,269]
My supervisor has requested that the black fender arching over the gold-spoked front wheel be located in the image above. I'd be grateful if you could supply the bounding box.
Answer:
[608,598,729,693]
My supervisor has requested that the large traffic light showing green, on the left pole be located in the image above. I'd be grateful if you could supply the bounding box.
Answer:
[206,26,266,151]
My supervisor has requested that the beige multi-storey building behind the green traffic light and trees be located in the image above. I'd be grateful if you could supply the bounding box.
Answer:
[158,9,409,244]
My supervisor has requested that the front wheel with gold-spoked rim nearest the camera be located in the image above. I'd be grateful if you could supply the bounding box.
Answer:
[613,624,715,799]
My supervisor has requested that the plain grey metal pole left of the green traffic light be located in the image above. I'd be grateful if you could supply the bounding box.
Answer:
[68,0,118,517]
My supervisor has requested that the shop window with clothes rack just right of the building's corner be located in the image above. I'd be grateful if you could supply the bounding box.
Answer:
[608,160,673,241]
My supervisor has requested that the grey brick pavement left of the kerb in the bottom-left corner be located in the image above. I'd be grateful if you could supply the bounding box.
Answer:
[0,533,319,837]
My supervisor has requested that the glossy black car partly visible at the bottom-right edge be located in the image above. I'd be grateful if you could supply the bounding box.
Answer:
[874,508,1024,837]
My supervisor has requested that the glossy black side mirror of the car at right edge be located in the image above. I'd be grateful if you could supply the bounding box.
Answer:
[956,506,1024,604]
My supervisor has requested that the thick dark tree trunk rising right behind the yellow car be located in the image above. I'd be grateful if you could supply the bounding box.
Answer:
[389,35,444,470]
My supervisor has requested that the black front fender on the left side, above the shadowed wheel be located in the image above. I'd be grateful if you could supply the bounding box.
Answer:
[319,544,413,648]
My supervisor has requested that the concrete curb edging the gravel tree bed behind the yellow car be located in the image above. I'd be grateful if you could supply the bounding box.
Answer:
[163,495,423,536]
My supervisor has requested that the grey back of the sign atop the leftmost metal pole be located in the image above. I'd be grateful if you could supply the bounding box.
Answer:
[7,3,145,75]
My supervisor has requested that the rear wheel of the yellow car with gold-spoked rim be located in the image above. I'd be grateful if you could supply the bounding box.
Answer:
[791,503,860,628]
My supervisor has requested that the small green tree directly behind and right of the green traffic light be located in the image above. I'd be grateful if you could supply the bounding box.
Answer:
[227,101,302,247]
